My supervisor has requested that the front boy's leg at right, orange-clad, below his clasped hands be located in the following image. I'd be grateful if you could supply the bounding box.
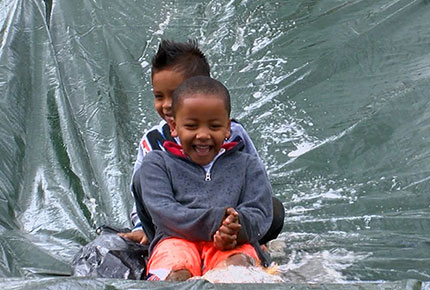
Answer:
[202,242,259,274]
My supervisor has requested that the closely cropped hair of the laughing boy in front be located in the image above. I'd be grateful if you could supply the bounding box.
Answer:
[172,76,231,117]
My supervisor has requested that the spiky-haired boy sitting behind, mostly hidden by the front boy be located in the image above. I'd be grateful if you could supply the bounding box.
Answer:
[121,40,284,249]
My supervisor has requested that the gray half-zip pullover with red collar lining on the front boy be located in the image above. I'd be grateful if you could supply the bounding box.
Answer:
[133,142,273,253]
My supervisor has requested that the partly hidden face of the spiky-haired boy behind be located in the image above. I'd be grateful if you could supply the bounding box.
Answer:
[152,69,185,121]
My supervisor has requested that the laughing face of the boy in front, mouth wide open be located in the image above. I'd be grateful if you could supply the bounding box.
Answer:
[169,94,230,165]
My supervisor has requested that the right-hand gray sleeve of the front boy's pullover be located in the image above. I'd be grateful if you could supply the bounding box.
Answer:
[236,156,273,243]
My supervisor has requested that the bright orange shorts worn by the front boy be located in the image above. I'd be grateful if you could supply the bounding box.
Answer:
[147,238,259,280]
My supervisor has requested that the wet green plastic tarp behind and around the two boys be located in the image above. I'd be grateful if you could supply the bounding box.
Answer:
[0,0,430,289]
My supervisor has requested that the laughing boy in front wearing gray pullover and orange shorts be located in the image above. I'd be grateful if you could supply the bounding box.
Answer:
[132,76,273,281]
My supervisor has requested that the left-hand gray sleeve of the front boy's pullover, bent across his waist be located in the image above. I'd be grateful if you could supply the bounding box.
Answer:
[136,151,225,241]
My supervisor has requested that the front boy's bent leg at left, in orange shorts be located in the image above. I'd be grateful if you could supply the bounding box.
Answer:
[147,238,201,281]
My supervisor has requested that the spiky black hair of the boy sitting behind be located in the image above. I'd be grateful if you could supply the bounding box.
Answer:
[151,40,210,79]
